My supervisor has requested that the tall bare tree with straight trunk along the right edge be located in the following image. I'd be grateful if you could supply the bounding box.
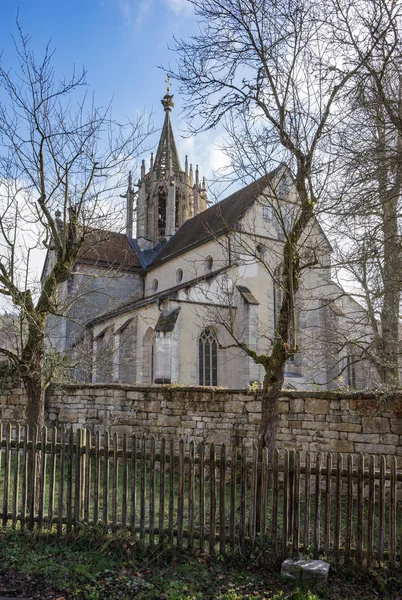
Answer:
[326,0,402,386]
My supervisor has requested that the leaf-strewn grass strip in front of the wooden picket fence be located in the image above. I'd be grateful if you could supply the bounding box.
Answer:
[0,526,402,600]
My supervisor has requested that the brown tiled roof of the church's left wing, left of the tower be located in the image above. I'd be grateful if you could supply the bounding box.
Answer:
[77,229,141,271]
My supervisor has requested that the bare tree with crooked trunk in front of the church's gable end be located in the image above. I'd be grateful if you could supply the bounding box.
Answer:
[169,0,390,448]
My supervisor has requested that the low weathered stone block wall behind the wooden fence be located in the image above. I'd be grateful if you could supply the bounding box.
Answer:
[0,384,402,456]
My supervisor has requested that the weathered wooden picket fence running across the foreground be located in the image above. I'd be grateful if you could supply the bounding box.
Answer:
[0,425,402,565]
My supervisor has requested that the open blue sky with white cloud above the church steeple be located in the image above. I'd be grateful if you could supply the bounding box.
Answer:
[0,0,222,185]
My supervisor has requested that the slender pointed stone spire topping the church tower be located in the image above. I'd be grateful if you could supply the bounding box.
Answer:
[154,75,182,175]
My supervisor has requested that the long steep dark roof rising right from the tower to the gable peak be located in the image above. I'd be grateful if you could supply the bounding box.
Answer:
[149,165,282,269]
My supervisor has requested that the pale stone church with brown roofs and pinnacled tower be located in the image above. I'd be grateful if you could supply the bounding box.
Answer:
[45,87,372,389]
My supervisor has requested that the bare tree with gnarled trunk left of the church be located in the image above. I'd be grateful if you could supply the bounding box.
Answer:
[0,24,146,427]
